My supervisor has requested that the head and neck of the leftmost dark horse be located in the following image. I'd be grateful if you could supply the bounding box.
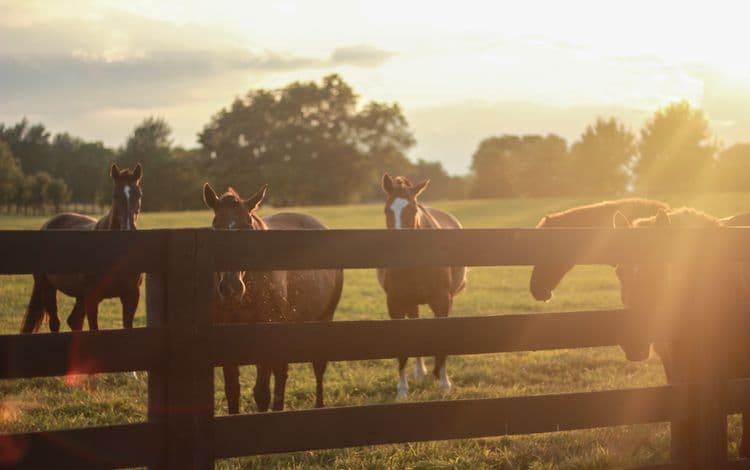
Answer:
[109,163,143,230]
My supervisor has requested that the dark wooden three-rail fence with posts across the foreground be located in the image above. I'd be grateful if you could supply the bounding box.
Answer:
[0,228,750,469]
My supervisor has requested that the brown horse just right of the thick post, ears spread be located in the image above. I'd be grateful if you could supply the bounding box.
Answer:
[203,183,344,414]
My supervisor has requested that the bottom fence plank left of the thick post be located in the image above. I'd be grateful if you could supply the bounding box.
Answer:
[0,423,161,469]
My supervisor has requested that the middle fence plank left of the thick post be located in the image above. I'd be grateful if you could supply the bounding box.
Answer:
[0,328,164,379]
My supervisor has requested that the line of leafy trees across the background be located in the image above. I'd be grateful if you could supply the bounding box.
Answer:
[0,75,750,212]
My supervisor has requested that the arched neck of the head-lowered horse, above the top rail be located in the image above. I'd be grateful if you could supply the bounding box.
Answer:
[537,198,669,228]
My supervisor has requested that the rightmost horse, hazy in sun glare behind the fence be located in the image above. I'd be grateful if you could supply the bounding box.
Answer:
[612,208,750,457]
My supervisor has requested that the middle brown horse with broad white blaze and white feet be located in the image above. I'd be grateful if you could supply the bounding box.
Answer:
[377,173,466,399]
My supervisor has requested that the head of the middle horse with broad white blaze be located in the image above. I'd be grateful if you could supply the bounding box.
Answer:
[381,173,430,229]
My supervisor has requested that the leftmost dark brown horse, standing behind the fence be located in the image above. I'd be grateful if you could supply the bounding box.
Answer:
[21,163,143,333]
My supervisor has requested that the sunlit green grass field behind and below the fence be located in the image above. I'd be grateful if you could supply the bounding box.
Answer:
[0,194,750,469]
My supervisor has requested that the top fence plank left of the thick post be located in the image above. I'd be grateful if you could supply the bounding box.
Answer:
[0,230,167,274]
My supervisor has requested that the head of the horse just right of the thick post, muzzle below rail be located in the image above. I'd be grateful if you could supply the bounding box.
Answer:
[203,183,268,305]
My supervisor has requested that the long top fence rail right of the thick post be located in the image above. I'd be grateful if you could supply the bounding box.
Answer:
[196,228,750,271]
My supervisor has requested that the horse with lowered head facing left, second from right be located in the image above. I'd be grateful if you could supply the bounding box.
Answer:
[529,198,669,302]
